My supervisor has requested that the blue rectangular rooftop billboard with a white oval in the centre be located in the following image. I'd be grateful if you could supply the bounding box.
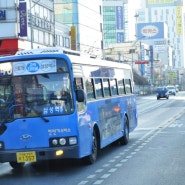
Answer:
[136,22,165,40]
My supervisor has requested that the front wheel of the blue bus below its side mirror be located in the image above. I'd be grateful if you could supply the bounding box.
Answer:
[83,130,98,164]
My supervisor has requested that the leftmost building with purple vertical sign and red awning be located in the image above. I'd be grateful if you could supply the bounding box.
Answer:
[0,0,70,55]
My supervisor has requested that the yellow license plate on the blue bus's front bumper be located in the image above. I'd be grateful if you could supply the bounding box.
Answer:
[17,152,36,163]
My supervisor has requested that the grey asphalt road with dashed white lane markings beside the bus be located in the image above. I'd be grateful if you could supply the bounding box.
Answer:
[0,92,185,185]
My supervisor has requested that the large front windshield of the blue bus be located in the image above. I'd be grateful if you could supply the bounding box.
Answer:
[0,60,73,123]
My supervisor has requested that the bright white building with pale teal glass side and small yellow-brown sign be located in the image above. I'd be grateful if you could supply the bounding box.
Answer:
[54,0,102,56]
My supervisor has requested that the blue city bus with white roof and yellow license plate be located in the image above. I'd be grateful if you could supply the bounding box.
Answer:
[0,48,137,169]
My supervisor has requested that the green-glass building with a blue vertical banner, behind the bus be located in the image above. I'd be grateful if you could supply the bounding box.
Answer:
[102,0,128,48]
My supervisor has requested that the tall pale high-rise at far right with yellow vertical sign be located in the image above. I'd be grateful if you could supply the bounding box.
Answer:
[137,0,185,69]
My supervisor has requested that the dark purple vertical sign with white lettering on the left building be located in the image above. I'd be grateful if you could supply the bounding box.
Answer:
[19,2,27,37]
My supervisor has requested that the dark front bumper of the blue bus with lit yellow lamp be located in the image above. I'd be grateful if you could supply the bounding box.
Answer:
[0,145,79,163]
